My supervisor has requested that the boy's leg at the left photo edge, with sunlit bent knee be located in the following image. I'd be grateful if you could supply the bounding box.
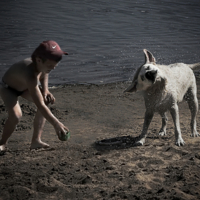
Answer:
[0,88,22,151]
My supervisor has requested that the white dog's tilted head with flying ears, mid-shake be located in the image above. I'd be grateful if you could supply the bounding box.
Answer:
[124,49,165,92]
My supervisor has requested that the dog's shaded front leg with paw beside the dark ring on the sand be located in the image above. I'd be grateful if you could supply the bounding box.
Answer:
[135,110,154,146]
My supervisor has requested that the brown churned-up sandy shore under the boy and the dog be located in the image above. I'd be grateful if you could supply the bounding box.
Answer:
[0,79,200,200]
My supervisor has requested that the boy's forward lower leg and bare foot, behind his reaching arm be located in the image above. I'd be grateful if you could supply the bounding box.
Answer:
[30,110,49,149]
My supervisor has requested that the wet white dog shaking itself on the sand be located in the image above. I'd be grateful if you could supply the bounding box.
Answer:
[124,49,200,146]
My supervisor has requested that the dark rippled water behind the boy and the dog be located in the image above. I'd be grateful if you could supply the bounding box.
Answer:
[0,0,200,85]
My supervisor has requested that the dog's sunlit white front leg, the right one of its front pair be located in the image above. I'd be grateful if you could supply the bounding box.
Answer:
[170,103,185,146]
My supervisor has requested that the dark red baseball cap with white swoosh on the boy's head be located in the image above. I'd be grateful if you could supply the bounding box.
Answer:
[31,40,68,63]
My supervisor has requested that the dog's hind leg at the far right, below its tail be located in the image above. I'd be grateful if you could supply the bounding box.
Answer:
[186,87,200,137]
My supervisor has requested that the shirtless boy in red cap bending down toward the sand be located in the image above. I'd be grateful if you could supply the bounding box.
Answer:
[0,40,69,151]
